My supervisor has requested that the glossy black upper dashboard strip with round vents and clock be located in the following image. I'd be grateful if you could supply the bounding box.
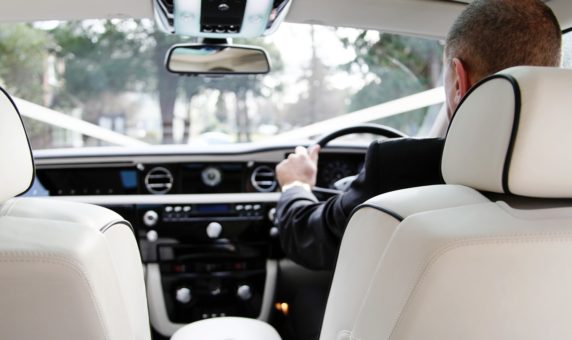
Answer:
[37,162,276,196]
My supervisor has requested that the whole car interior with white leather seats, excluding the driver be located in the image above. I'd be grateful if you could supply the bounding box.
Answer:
[0,0,572,340]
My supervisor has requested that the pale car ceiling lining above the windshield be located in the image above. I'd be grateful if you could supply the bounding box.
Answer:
[0,0,572,38]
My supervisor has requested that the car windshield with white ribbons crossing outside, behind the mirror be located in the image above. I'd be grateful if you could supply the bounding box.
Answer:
[0,20,443,149]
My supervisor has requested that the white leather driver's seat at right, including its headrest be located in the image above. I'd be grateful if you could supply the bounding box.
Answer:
[320,67,572,340]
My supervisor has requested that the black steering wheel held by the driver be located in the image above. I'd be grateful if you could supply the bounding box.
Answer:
[312,124,408,196]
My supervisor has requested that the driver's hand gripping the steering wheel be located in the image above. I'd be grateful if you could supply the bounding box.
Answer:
[276,145,320,187]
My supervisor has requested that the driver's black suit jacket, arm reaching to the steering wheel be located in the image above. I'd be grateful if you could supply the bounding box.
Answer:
[276,138,444,269]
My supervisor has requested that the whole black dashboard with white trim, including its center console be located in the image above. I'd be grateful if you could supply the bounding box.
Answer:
[26,145,366,337]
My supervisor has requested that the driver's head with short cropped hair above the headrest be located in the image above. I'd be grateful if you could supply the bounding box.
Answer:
[444,0,562,117]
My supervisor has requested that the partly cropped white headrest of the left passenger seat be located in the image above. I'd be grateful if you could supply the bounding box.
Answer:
[0,88,34,204]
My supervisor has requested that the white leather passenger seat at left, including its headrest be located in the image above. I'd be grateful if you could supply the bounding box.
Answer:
[0,90,150,340]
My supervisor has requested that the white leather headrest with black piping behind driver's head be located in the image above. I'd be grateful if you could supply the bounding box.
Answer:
[441,67,572,198]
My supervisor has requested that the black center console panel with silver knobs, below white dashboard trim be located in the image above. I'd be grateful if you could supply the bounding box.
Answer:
[136,202,279,324]
